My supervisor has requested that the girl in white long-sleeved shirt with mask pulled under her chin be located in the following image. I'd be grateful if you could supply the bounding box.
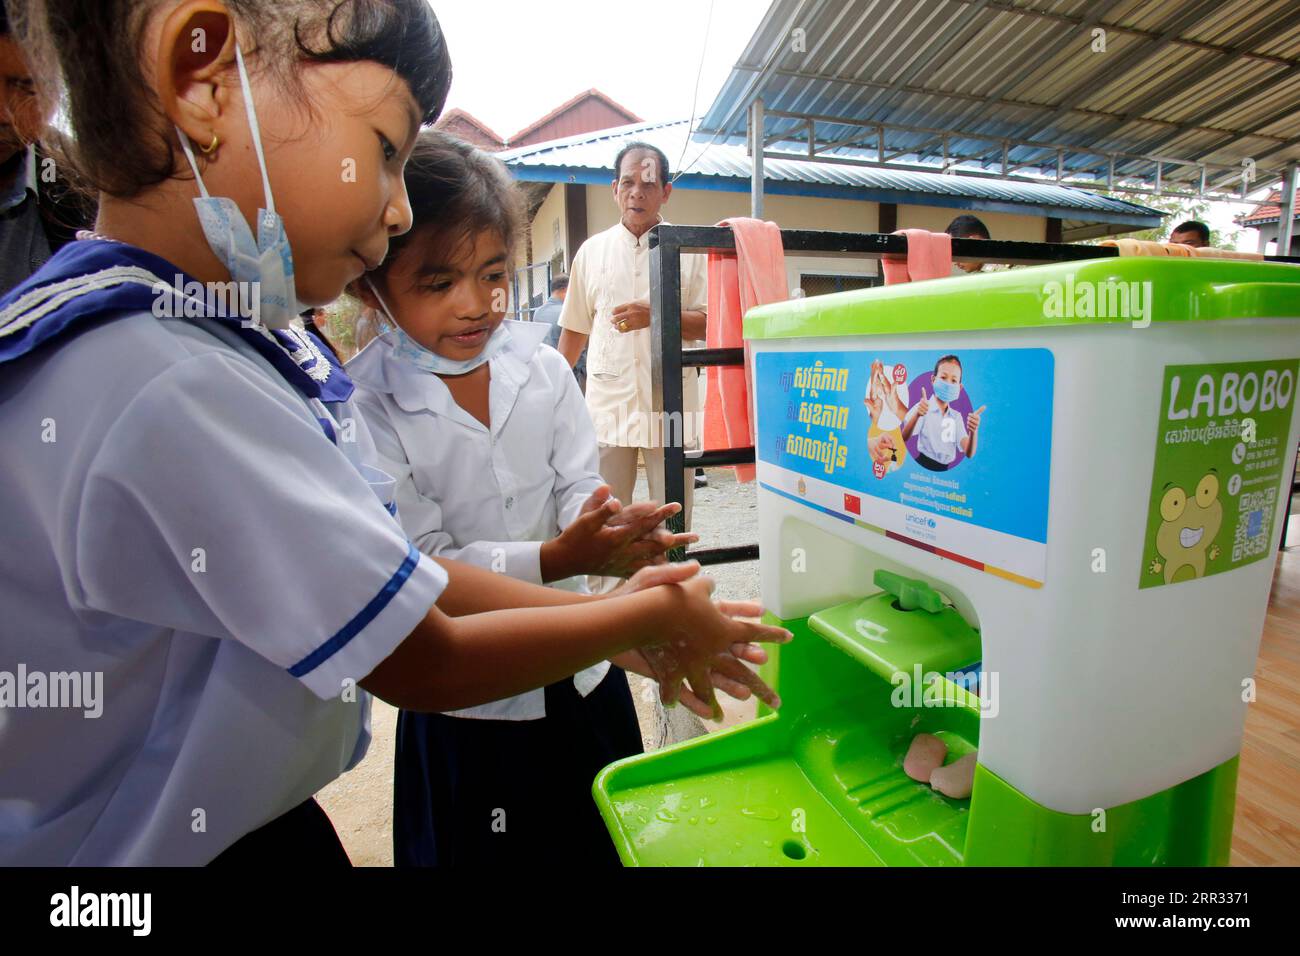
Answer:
[348,130,775,865]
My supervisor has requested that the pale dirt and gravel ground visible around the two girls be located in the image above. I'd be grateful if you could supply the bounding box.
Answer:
[316,468,759,866]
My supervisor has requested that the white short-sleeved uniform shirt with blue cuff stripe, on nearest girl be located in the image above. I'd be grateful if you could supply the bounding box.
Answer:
[0,313,447,866]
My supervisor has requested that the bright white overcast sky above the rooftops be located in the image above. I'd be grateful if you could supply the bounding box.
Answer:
[430,0,1279,251]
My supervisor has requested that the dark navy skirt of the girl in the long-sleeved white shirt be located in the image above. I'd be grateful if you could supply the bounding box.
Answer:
[393,666,642,868]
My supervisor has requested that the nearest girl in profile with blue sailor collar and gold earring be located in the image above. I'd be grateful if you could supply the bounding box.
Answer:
[0,0,788,866]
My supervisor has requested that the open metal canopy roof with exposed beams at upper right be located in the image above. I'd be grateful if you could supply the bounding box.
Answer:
[699,0,1300,197]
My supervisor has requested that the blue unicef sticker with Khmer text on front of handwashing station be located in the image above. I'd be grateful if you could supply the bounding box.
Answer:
[754,349,1054,587]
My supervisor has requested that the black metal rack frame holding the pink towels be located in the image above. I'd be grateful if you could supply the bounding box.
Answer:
[650,225,1300,564]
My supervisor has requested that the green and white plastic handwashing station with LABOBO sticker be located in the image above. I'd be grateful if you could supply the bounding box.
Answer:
[593,258,1300,866]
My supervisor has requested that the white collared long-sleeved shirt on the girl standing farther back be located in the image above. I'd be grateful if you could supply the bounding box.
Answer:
[347,321,610,721]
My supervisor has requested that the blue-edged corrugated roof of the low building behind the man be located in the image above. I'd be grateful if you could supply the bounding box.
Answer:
[497,120,1162,229]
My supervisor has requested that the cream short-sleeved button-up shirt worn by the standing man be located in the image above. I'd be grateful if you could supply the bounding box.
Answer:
[560,220,709,447]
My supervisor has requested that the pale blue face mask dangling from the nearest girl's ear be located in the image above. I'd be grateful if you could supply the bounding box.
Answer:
[176,43,302,329]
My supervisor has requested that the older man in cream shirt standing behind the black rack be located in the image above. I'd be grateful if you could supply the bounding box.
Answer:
[559,142,709,528]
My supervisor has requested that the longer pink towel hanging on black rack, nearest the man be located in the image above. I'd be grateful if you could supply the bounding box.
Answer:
[703,219,789,481]
